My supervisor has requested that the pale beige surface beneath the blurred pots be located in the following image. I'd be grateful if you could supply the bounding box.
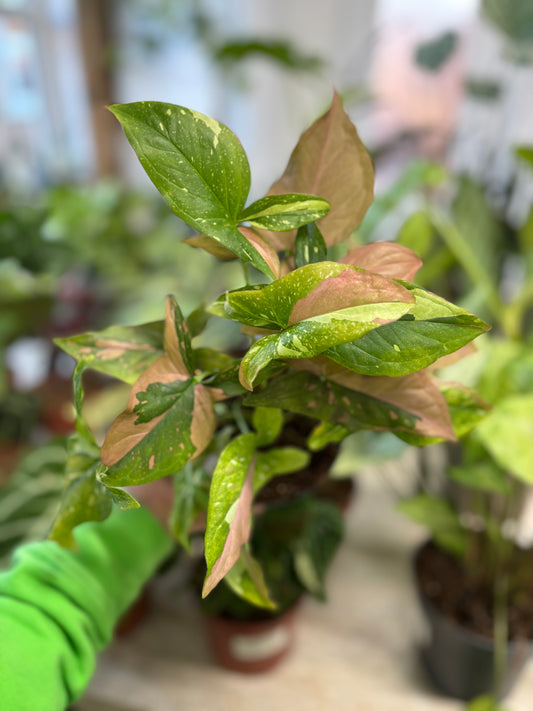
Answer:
[76,462,533,711]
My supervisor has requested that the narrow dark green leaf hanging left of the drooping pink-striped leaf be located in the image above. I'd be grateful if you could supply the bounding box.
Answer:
[170,463,211,551]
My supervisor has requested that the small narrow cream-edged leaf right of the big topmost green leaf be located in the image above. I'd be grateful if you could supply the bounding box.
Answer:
[239,193,329,232]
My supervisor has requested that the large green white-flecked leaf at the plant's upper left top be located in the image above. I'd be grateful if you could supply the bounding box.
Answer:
[110,101,274,278]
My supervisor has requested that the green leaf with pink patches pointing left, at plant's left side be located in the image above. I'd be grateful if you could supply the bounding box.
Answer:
[54,321,164,385]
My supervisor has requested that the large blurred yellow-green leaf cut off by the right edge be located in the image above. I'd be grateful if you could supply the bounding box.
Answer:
[475,393,533,484]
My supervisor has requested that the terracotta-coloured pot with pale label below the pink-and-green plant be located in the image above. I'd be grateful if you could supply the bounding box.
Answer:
[205,605,299,674]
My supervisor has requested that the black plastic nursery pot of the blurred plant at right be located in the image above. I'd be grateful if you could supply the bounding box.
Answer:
[414,543,533,701]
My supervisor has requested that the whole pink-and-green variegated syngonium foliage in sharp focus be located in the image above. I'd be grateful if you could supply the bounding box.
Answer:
[51,95,488,607]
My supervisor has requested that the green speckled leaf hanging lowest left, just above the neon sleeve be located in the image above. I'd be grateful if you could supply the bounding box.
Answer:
[48,464,113,548]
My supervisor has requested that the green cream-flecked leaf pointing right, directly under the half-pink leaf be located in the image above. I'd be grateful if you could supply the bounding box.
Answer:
[325,284,489,377]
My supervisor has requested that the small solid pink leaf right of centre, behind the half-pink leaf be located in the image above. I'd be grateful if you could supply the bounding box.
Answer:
[339,242,422,281]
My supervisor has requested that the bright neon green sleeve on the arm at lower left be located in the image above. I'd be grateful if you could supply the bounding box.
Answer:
[0,509,172,711]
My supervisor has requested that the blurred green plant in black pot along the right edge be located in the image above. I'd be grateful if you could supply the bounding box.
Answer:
[394,148,533,704]
